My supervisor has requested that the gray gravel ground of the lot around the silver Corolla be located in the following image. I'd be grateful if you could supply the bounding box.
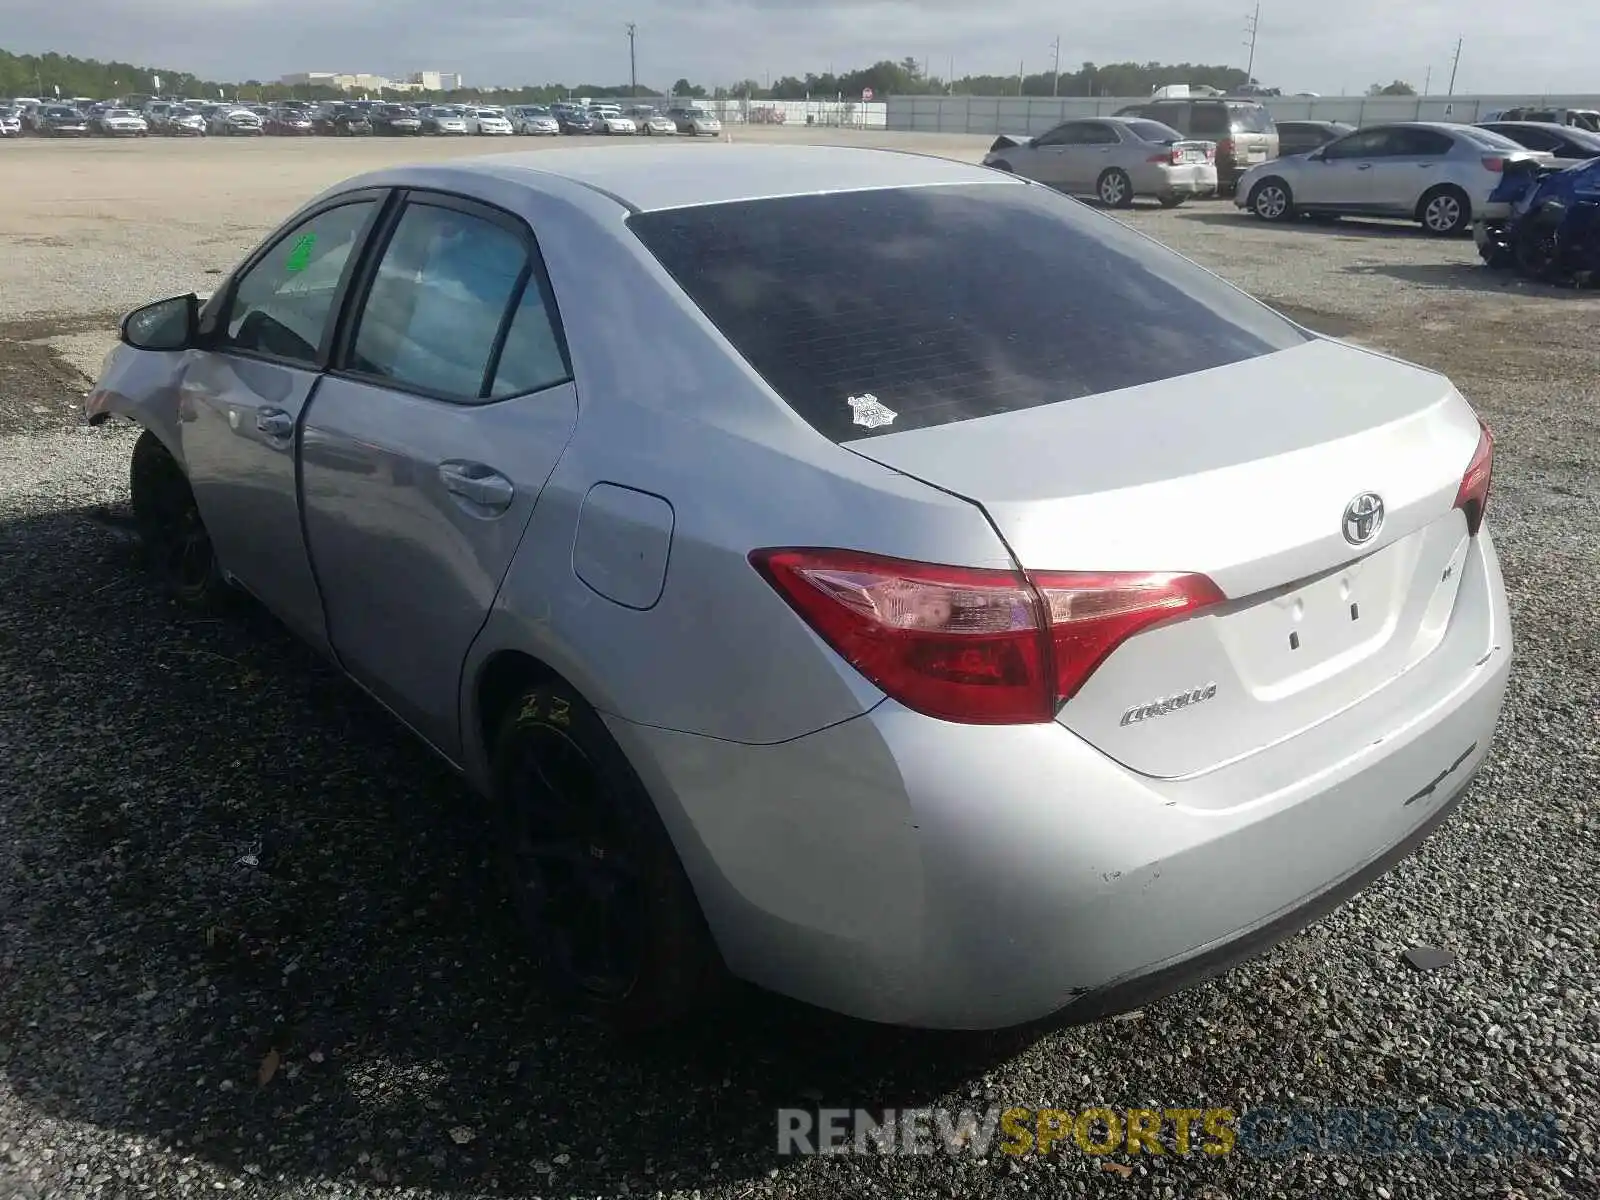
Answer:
[0,131,1600,1200]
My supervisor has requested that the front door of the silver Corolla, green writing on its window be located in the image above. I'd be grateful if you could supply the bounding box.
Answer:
[179,189,387,646]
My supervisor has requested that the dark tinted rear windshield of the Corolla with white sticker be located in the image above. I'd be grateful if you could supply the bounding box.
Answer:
[629,182,1307,442]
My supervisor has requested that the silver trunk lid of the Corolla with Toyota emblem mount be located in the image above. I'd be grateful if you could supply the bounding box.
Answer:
[846,339,1480,778]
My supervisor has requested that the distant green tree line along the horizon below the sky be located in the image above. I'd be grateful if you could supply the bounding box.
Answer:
[0,50,1273,104]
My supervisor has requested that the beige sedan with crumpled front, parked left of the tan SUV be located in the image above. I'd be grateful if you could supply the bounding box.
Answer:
[984,117,1216,208]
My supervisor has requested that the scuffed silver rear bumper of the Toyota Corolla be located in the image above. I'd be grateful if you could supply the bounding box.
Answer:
[611,536,1512,1029]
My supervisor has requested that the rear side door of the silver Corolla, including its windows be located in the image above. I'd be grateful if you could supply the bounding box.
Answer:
[301,192,578,757]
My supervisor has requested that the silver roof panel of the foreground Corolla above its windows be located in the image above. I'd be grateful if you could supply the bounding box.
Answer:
[371,144,1026,211]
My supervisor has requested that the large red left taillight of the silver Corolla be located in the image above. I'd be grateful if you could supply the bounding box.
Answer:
[750,549,1222,725]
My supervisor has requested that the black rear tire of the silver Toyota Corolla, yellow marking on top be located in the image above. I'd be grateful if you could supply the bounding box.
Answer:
[491,682,723,1032]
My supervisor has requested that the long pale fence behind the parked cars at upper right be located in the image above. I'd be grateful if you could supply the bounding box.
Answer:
[896,96,1600,133]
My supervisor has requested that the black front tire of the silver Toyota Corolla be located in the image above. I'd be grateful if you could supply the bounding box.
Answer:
[128,429,238,613]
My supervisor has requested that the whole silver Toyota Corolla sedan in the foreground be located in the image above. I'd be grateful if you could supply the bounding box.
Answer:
[86,144,1512,1027]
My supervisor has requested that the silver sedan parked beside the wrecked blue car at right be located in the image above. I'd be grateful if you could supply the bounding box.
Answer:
[1234,122,1550,237]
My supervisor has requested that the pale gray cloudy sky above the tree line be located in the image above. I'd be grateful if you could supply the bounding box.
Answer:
[12,0,1600,96]
